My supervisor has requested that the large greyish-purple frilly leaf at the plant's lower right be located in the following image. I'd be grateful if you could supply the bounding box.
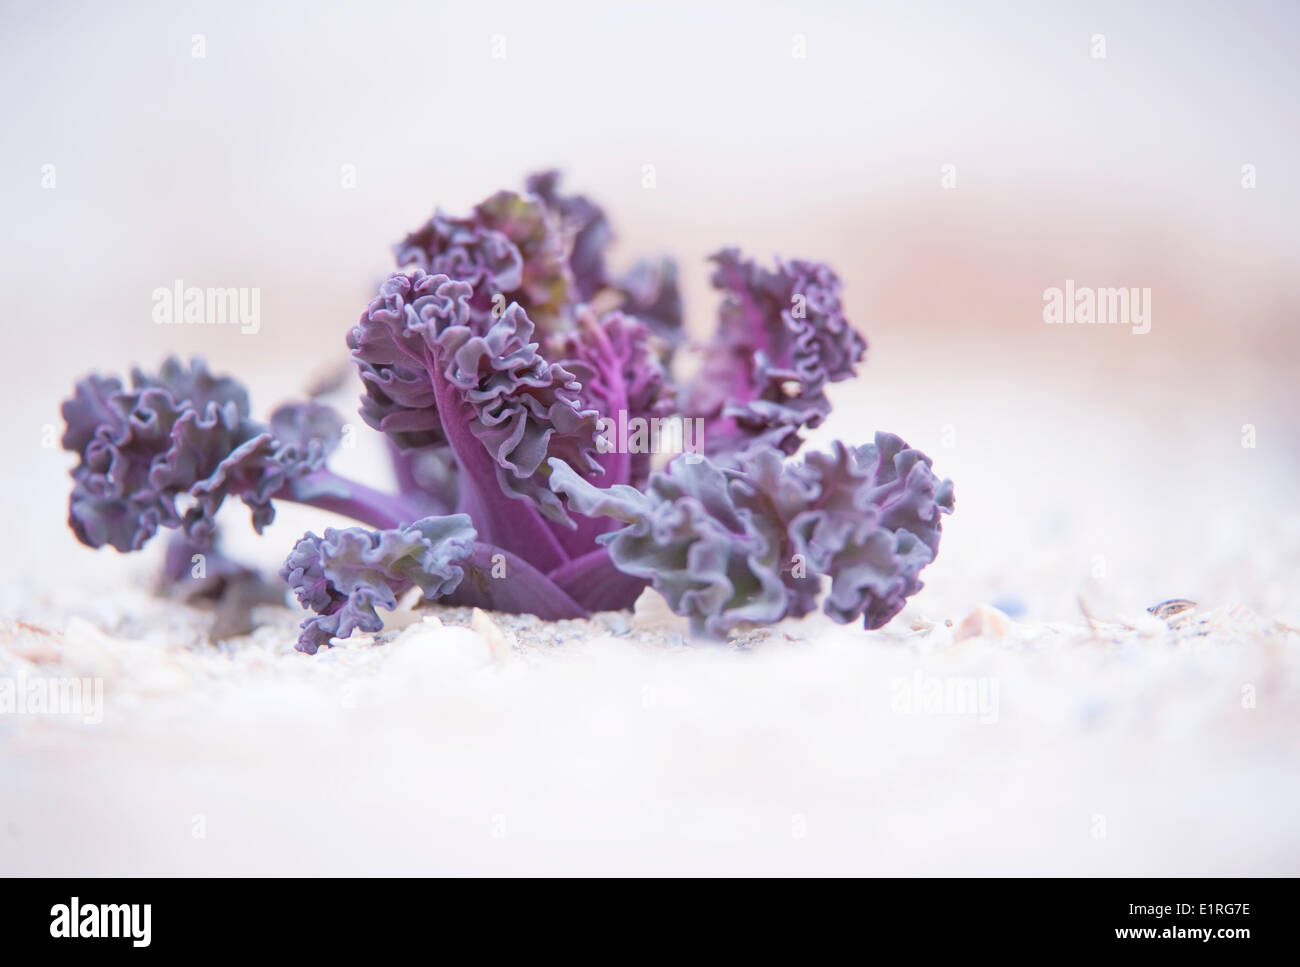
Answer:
[551,433,953,636]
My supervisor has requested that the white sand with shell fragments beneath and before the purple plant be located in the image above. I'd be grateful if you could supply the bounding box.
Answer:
[0,582,1300,875]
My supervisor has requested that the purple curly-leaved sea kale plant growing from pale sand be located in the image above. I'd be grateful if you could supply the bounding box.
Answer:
[62,172,953,654]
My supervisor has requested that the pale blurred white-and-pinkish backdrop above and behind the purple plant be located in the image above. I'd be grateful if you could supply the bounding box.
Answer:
[0,0,1300,620]
